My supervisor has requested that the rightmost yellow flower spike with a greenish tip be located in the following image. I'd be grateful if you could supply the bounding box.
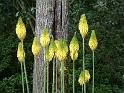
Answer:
[89,30,98,51]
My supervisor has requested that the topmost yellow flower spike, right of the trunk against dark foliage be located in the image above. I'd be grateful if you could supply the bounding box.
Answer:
[79,14,88,38]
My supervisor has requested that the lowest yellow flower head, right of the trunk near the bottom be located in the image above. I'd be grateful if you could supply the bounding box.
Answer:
[78,70,90,85]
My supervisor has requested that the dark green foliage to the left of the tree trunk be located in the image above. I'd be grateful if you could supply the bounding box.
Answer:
[0,0,35,93]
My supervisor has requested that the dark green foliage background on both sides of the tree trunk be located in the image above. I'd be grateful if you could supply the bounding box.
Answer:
[0,0,124,93]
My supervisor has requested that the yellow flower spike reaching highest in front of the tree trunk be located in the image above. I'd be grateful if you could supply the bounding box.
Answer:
[40,28,50,48]
